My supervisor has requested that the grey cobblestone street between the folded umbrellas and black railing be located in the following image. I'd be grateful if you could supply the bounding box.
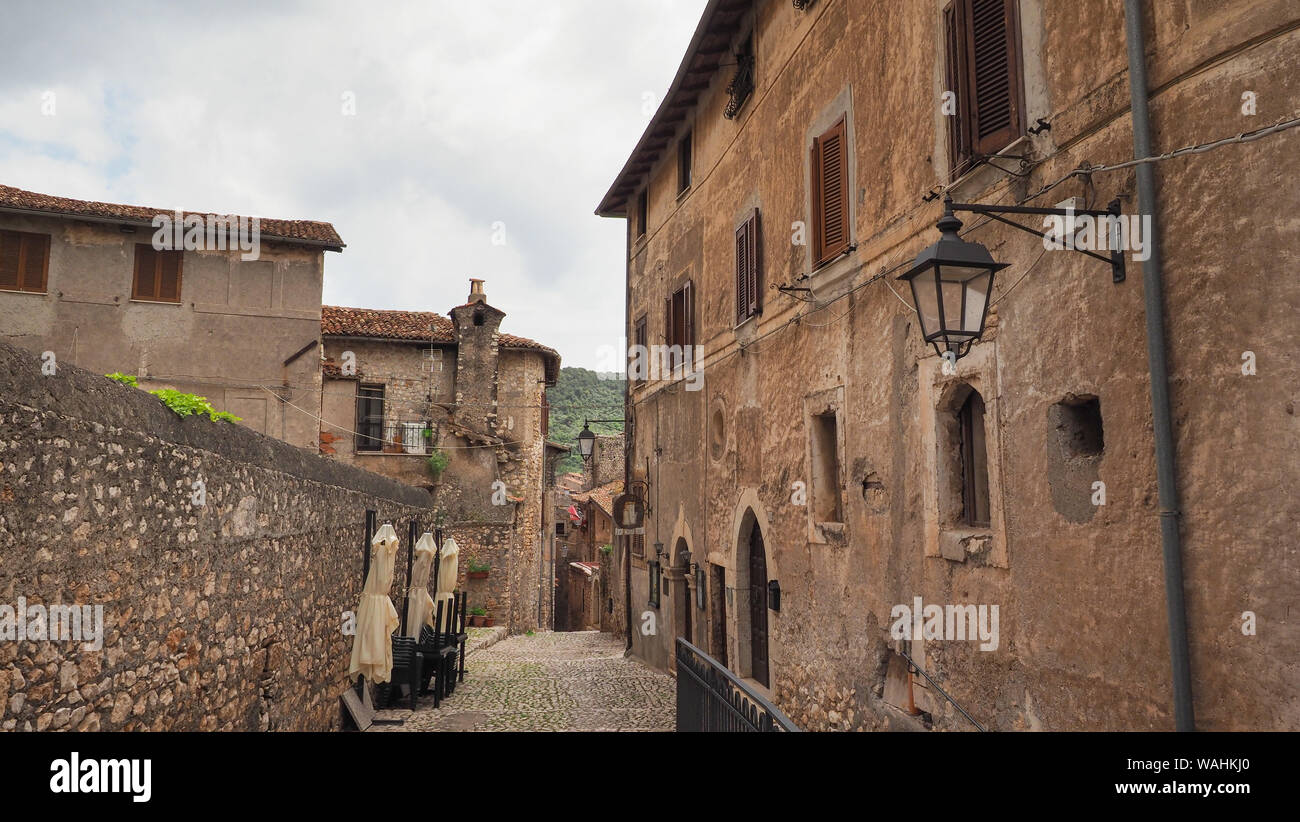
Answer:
[372,631,675,731]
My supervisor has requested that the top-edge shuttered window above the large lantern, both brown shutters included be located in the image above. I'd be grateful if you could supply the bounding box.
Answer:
[944,0,1024,177]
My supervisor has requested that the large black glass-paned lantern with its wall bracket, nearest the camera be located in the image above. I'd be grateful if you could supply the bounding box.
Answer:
[898,198,1125,360]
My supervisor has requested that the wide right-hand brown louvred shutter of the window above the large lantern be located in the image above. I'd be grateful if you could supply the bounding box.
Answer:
[959,0,1022,155]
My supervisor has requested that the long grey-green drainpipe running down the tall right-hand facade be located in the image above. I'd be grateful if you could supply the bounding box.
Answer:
[1125,0,1196,731]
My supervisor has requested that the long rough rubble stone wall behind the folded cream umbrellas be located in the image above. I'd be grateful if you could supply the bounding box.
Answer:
[0,343,432,730]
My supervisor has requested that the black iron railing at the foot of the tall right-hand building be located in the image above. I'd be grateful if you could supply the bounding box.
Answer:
[677,637,800,731]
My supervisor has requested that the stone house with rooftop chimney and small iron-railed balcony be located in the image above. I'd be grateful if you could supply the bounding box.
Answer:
[320,280,559,631]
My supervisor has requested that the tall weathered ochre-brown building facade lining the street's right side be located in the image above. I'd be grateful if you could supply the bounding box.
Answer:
[597,0,1300,730]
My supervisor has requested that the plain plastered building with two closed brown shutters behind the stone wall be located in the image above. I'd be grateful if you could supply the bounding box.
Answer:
[0,186,343,450]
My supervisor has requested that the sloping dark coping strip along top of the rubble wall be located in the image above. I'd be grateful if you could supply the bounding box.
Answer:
[0,339,433,509]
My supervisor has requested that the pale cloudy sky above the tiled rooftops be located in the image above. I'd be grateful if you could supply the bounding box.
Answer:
[0,0,705,368]
